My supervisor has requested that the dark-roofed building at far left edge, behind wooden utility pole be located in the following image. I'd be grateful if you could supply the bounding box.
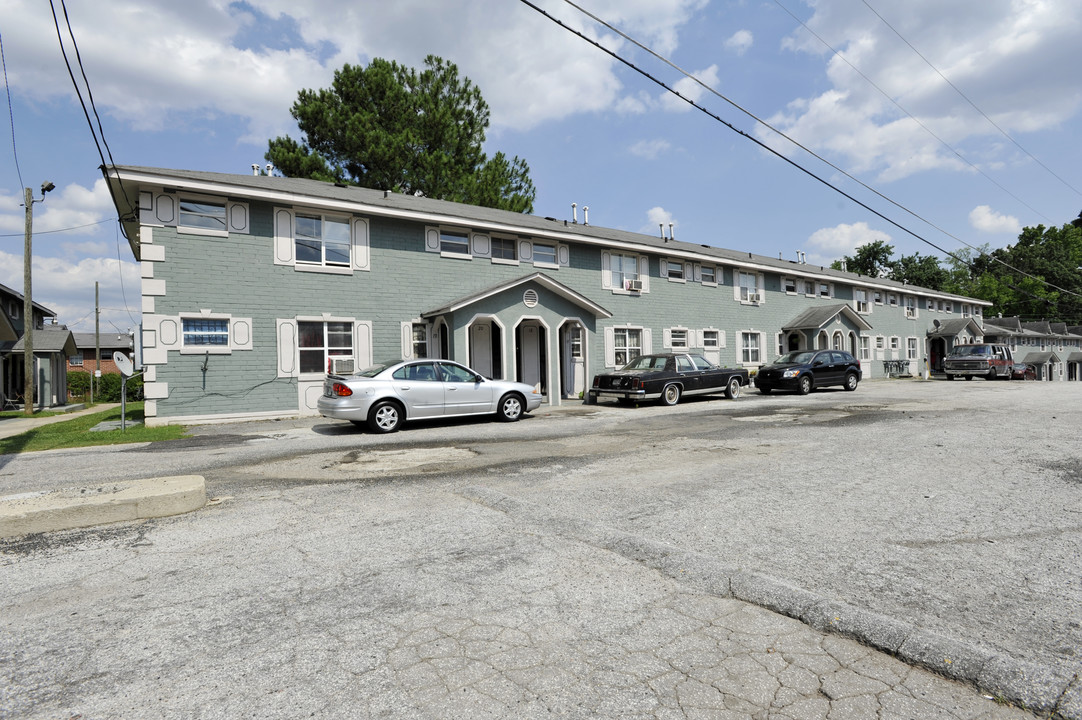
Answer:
[0,285,76,410]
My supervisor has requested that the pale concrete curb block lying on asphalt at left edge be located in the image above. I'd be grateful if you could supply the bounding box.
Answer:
[0,475,207,537]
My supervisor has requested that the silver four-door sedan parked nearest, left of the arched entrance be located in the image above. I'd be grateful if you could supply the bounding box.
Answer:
[316,359,542,432]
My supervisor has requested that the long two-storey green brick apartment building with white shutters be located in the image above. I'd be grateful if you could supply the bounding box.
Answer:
[106,167,990,424]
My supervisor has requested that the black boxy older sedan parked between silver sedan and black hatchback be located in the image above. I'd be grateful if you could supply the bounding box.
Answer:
[590,353,748,405]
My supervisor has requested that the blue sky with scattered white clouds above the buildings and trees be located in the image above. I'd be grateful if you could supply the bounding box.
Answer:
[0,0,1082,331]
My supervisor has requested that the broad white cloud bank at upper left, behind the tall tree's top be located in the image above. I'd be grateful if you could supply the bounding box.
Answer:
[3,0,705,138]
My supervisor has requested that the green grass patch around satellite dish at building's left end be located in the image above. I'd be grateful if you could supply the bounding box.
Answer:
[0,403,187,455]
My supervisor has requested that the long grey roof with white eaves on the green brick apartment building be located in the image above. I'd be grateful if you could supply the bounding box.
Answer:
[105,166,991,305]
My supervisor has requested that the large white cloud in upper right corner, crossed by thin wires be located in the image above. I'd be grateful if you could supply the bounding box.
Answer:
[770,0,1082,181]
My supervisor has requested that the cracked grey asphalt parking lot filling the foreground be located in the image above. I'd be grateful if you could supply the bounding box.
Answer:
[0,381,1082,718]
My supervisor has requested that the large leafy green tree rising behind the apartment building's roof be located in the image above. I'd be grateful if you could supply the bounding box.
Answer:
[265,55,537,212]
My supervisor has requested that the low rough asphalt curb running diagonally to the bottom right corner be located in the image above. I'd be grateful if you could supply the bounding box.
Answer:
[460,486,1082,720]
